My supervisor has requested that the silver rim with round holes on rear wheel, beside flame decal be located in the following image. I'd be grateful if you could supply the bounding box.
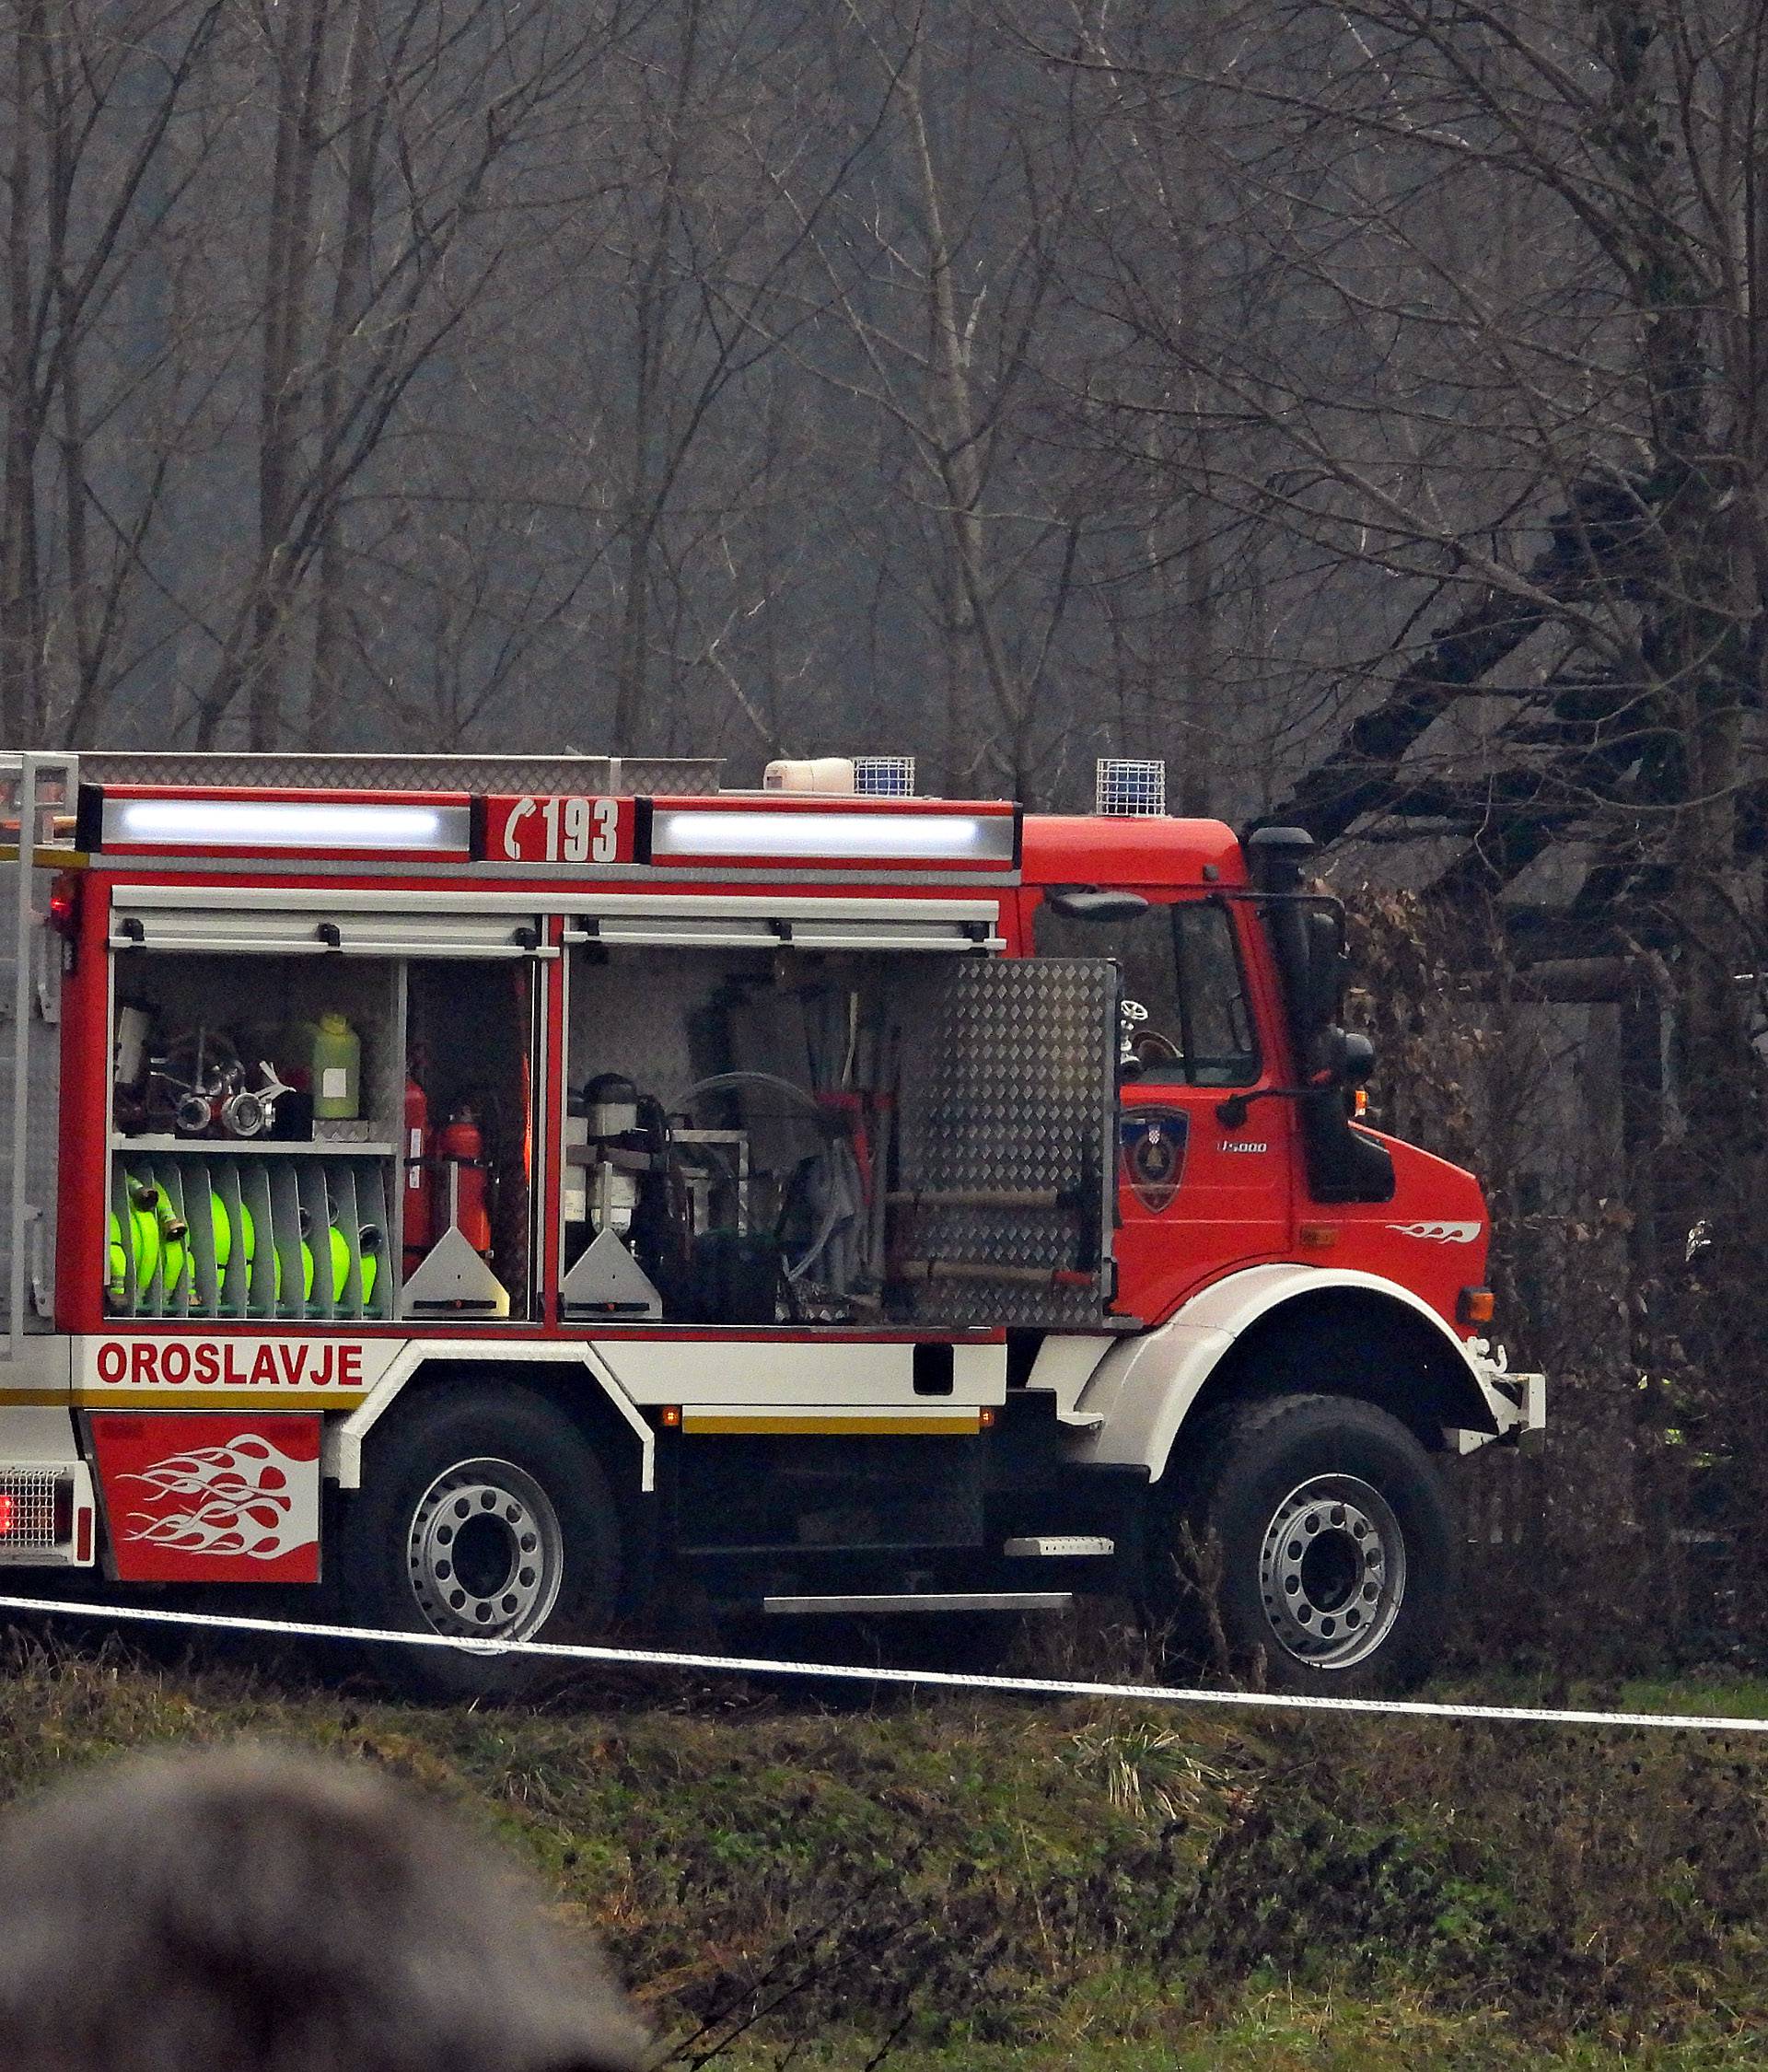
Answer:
[406,1461,564,1641]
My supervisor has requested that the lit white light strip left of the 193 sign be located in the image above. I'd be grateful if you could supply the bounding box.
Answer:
[101,797,472,856]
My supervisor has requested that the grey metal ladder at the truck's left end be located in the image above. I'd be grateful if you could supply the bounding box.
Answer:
[0,752,79,1366]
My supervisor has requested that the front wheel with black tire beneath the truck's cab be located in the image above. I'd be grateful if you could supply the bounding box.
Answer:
[1150,1394,1457,1697]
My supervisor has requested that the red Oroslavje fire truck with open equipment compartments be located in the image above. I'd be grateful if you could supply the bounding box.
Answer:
[0,752,1542,1693]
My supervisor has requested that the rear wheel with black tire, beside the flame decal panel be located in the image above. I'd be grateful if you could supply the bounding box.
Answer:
[338,1382,622,1697]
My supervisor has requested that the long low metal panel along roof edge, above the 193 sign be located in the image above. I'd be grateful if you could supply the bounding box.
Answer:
[79,748,724,797]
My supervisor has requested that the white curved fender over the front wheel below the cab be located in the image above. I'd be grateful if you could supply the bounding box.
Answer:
[1074,1266,1498,1482]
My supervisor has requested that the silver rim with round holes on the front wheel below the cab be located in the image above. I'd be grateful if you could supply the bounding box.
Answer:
[1258,1475,1405,1670]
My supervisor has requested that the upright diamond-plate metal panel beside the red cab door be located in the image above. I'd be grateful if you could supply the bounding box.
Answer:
[891,960,1117,1328]
